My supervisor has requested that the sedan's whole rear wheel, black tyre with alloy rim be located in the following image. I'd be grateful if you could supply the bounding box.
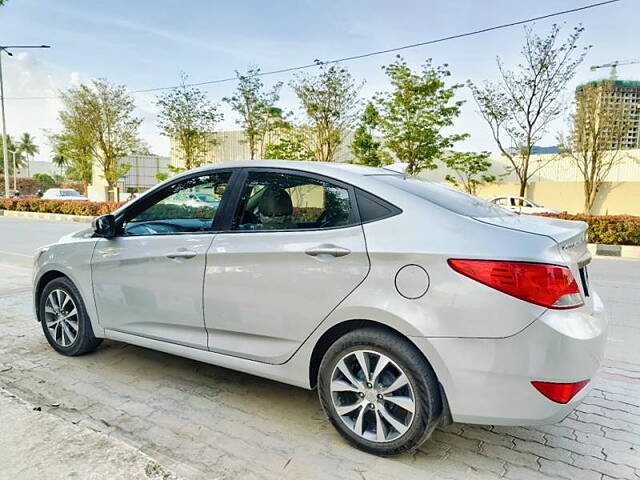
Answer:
[318,328,443,456]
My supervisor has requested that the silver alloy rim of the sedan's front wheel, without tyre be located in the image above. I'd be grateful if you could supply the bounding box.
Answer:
[44,289,79,347]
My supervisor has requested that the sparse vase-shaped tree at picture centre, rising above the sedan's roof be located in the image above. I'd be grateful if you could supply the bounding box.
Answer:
[289,60,362,162]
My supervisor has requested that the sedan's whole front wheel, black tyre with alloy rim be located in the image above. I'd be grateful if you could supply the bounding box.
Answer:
[38,277,102,356]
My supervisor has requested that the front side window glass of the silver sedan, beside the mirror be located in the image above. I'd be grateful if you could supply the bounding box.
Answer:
[124,173,231,235]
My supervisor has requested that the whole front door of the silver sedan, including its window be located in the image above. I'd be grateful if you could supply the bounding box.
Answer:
[91,172,231,349]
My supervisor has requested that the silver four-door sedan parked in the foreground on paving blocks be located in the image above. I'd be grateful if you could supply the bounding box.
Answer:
[34,161,607,455]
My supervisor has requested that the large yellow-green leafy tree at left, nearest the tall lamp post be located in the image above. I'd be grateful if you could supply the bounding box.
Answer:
[58,79,142,190]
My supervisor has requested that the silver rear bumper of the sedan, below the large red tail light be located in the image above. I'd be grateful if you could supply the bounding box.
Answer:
[412,292,608,425]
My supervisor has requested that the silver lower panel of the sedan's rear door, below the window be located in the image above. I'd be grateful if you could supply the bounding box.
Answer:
[204,225,369,363]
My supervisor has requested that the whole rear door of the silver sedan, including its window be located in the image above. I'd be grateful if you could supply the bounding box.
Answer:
[204,169,369,363]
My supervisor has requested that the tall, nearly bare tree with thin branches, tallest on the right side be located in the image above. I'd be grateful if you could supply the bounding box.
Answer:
[469,25,590,197]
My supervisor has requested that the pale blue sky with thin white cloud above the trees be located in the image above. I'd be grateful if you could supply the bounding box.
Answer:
[0,0,640,160]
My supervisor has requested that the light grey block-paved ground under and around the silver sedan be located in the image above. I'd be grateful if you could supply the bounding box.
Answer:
[0,260,640,480]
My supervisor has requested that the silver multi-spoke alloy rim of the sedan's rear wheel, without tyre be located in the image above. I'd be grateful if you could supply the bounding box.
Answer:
[330,350,416,443]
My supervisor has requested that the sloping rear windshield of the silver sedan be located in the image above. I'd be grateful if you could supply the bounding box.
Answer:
[375,175,515,217]
